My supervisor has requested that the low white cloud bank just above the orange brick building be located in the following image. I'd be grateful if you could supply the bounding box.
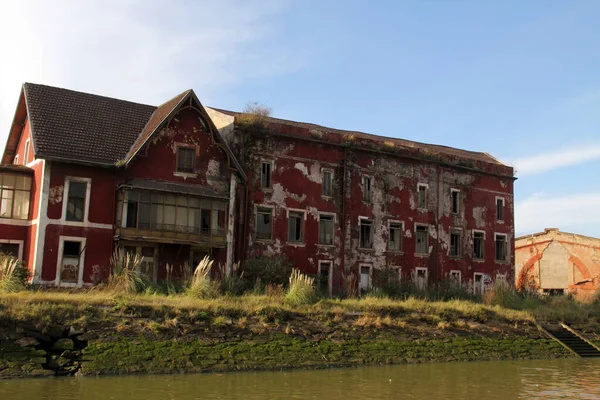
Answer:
[515,192,600,237]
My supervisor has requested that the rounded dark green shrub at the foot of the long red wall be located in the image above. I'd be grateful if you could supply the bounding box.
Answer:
[243,257,292,292]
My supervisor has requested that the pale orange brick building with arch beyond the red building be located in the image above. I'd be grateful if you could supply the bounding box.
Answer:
[515,228,600,299]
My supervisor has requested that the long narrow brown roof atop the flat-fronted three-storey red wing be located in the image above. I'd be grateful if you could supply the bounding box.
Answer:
[211,107,505,166]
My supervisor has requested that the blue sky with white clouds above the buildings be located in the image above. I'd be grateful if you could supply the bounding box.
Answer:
[0,0,600,237]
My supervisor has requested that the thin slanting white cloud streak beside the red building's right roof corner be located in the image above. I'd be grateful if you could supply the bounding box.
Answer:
[511,143,600,177]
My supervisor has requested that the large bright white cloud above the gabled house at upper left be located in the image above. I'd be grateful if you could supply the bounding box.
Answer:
[0,0,302,148]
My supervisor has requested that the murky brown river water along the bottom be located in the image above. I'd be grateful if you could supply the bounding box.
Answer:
[0,359,600,400]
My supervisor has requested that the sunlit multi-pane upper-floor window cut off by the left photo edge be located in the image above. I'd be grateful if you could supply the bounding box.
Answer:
[0,173,31,219]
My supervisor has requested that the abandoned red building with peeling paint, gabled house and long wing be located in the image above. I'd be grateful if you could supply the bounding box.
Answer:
[0,83,514,293]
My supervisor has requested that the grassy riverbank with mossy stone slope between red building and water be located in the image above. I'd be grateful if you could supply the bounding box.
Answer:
[0,291,589,377]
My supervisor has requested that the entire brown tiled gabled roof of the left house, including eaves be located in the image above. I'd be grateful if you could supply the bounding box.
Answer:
[2,83,246,179]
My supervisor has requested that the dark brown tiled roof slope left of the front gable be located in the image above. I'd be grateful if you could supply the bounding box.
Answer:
[23,83,157,165]
